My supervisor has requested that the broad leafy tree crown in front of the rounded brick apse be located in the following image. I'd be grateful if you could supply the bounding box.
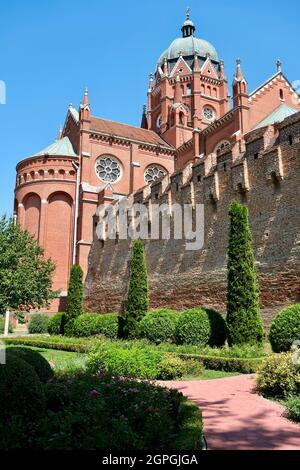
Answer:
[0,217,57,313]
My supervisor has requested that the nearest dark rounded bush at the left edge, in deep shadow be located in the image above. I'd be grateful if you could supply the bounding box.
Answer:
[0,354,46,422]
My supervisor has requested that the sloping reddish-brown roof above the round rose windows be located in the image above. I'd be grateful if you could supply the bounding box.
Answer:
[91,117,173,148]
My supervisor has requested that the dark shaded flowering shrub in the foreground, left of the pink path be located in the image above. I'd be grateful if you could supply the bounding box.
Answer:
[32,373,202,451]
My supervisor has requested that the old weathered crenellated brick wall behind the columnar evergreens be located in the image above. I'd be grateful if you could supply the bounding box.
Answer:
[85,113,300,324]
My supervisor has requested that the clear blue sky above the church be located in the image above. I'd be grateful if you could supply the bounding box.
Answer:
[0,0,300,215]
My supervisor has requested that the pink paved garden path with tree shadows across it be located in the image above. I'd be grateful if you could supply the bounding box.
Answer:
[164,375,300,450]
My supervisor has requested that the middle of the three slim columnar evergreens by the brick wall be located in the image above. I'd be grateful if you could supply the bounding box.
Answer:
[123,240,149,337]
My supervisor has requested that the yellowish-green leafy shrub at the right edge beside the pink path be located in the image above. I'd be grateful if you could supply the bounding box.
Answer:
[257,353,300,398]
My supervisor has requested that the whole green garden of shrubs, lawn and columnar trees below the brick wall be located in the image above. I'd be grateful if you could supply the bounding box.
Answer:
[0,202,300,450]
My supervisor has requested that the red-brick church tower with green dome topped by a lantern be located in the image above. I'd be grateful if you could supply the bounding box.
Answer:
[147,9,230,148]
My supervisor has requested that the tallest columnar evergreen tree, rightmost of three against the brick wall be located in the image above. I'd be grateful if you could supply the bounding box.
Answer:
[226,201,264,345]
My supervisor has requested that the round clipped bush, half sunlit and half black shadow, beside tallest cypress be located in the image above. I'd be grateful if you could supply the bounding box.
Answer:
[176,307,226,346]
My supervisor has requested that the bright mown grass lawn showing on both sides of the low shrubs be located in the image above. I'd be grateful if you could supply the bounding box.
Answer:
[8,346,239,380]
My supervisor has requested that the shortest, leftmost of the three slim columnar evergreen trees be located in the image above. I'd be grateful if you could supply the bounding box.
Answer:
[66,264,83,323]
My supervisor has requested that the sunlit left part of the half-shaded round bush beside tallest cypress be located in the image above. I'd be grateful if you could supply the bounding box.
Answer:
[176,308,211,346]
